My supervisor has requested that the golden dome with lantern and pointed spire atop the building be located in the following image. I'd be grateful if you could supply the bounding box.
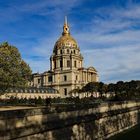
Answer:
[54,18,79,51]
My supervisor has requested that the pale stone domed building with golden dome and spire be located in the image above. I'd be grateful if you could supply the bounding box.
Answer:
[33,18,99,98]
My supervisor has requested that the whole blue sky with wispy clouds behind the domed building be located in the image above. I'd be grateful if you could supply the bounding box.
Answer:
[0,0,140,83]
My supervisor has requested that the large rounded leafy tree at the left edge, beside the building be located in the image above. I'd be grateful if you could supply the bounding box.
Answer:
[0,42,31,93]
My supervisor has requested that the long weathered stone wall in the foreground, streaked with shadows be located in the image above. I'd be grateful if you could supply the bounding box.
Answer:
[0,101,140,140]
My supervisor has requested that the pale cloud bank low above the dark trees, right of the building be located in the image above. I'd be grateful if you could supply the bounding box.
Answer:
[83,45,140,82]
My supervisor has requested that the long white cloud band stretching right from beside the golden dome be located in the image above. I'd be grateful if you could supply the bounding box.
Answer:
[76,30,140,47]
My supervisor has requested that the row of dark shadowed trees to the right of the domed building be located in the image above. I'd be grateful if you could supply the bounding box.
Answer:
[71,80,140,101]
